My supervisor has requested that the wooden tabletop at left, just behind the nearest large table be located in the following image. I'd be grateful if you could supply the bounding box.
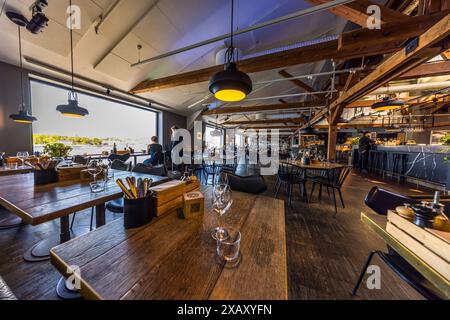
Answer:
[0,170,170,225]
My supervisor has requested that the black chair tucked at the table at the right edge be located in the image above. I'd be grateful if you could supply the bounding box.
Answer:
[352,187,444,300]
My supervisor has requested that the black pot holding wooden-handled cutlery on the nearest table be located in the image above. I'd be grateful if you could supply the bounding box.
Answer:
[123,195,155,229]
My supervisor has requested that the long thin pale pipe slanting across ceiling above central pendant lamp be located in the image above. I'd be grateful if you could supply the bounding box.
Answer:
[131,0,355,67]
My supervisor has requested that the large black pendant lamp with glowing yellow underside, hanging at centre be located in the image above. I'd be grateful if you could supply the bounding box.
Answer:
[209,0,253,102]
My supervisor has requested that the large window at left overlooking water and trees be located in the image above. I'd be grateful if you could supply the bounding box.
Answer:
[31,80,158,155]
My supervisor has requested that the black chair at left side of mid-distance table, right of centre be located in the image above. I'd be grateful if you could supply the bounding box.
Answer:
[275,162,308,206]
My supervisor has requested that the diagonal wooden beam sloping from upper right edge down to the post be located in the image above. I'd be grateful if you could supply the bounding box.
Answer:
[312,14,450,124]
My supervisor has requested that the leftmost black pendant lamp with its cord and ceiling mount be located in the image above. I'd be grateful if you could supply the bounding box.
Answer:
[6,11,37,124]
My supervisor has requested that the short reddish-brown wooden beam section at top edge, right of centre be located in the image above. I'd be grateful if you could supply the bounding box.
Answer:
[307,0,408,28]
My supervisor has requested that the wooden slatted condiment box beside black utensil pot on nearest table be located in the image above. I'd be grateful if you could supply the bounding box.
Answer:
[150,180,200,217]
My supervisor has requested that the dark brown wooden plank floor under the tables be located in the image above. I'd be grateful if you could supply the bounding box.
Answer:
[0,174,428,300]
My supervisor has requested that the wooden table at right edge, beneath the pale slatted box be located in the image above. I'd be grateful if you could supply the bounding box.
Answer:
[361,212,450,299]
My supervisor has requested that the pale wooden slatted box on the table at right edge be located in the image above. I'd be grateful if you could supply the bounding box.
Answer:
[386,211,450,280]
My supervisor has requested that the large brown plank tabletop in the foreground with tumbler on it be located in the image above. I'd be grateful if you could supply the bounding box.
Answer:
[51,187,287,300]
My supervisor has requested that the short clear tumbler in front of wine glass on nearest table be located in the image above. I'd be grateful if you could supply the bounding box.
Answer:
[217,228,241,268]
